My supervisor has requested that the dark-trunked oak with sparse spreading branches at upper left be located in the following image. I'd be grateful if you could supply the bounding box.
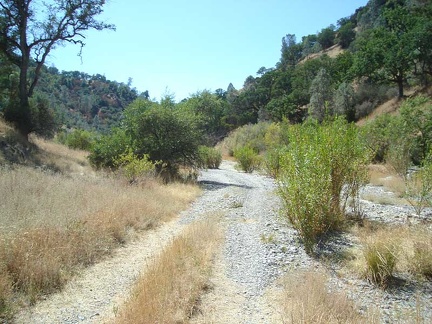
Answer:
[0,0,115,137]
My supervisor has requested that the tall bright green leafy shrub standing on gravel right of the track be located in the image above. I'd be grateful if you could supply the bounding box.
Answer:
[278,119,369,253]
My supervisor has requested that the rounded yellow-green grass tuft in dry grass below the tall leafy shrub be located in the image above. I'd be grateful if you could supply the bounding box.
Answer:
[363,240,397,286]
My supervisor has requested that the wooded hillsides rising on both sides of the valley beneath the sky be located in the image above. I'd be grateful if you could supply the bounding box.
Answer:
[0,0,432,138]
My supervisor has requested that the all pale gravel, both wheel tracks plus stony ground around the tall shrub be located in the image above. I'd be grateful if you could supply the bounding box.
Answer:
[11,161,432,323]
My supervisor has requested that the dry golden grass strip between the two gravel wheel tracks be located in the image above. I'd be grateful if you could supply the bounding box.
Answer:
[116,221,220,323]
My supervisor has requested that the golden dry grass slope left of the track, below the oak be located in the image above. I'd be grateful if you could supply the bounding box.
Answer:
[0,125,199,319]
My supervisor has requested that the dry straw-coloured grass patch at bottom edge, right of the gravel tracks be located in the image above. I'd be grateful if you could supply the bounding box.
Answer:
[282,271,378,324]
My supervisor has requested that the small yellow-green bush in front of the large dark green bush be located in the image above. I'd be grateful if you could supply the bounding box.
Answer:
[114,150,155,184]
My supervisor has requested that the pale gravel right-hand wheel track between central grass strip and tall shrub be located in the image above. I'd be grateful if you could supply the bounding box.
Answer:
[191,162,285,324]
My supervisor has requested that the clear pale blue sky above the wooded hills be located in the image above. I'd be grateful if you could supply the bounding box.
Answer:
[47,0,367,101]
